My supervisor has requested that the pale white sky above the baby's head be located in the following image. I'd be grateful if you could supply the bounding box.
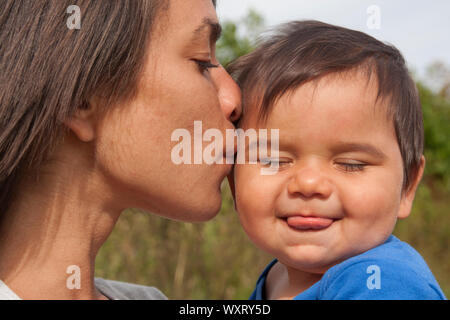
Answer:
[217,0,450,77]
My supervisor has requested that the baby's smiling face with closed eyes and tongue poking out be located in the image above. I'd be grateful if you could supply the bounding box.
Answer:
[234,73,409,273]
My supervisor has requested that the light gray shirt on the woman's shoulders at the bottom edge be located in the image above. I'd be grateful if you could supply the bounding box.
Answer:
[0,278,167,300]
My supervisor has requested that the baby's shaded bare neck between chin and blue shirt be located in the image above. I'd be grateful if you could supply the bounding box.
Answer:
[265,262,323,300]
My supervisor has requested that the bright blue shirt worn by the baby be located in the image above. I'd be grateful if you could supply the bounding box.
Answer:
[250,235,446,300]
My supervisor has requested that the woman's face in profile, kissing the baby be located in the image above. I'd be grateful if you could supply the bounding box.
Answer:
[96,0,241,221]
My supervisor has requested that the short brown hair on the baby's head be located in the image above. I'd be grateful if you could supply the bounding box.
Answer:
[228,21,424,191]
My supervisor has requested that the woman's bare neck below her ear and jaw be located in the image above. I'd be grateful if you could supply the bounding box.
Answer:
[0,139,120,299]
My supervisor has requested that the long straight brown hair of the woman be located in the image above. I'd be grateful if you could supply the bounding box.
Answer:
[0,0,169,212]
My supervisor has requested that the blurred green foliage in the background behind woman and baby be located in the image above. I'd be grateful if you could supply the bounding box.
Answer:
[96,11,450,299]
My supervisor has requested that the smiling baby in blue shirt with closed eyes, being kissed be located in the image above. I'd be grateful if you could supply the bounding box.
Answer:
[229,21,445,300]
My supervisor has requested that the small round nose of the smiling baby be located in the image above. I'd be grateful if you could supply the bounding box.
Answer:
[288,168,332,199]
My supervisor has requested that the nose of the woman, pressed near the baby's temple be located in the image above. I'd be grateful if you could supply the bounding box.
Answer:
[211,65,242,122]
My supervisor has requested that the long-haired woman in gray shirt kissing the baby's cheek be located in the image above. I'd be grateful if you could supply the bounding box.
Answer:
[0,0,241,299]
